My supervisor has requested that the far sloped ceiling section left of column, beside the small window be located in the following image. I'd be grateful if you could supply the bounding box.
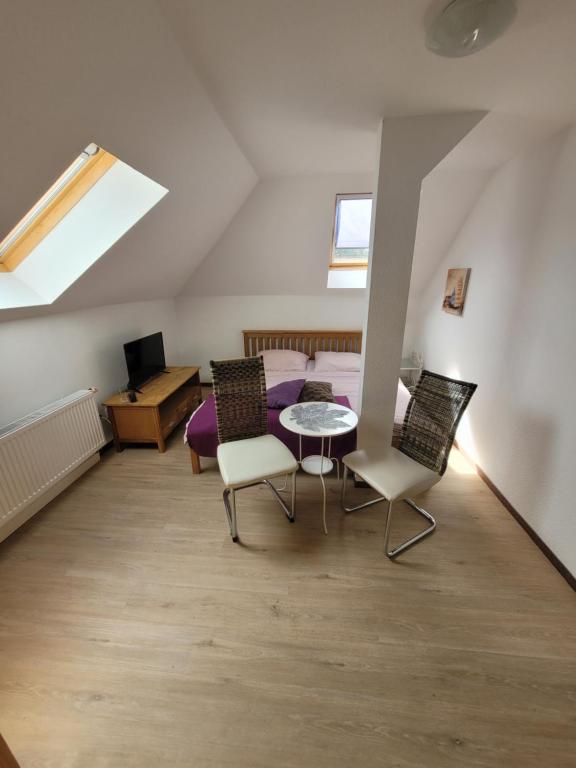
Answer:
[182,173,373,296]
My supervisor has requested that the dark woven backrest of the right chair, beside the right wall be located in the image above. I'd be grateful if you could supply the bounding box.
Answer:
[398,370,478,475]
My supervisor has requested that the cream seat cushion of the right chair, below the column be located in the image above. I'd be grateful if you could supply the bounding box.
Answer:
[343,448,441,501]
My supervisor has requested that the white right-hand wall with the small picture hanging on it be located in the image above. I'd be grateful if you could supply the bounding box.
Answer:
[417,130,576,574]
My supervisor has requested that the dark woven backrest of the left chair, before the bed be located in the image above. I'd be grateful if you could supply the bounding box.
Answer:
[210,357,268,443]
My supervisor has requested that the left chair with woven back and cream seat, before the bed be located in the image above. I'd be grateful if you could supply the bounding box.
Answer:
[210,357,298,541]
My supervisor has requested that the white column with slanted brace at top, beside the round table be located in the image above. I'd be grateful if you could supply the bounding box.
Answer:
[359,112,486,448]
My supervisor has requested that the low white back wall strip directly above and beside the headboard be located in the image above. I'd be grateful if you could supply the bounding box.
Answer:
[176,295,365,381]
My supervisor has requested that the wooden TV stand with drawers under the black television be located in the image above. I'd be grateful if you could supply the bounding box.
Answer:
[104,365,202,453]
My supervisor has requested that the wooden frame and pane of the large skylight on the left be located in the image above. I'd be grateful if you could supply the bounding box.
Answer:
[0,144,117,272]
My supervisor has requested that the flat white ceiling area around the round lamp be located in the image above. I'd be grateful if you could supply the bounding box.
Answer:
[159,0,576,176]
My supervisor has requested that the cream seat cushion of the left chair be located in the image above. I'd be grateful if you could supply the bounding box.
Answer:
[216,435,298,488]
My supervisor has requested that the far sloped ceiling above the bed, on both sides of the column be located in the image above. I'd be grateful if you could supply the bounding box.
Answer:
[182,162,492,304]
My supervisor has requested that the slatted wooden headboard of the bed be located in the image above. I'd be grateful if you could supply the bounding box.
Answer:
[242,331,362,360]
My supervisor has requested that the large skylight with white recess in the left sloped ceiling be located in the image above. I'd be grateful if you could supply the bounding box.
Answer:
[0,144,168,309]
